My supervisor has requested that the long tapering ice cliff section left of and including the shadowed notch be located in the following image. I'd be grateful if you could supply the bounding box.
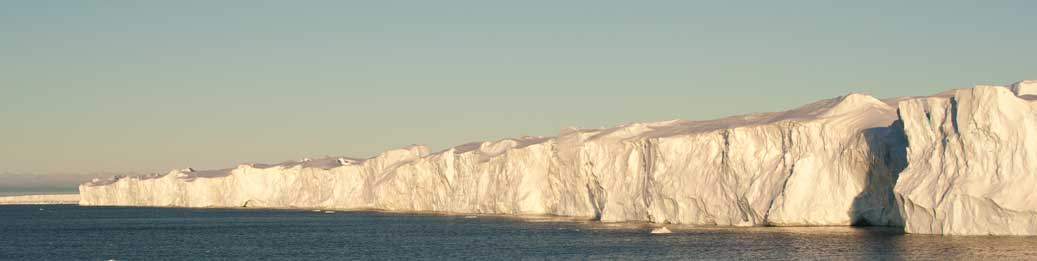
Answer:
[80,94,908,226]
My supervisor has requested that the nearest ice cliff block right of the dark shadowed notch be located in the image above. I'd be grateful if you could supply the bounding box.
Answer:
[896,85,1037,235]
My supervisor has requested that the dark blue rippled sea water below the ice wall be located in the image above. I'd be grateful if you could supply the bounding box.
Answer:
[0,205,1037,260]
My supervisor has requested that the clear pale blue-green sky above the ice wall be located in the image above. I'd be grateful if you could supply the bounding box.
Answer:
[0,0,1037,191]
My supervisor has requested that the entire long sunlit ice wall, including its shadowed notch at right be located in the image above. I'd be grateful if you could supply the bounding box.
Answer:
[80,81,1037,235]
